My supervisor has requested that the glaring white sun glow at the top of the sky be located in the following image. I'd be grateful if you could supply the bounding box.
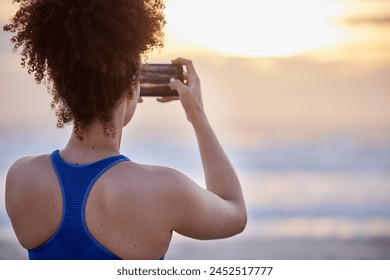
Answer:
[166,0,350,56]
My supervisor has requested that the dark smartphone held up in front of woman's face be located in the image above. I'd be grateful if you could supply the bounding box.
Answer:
[139,64,184,97]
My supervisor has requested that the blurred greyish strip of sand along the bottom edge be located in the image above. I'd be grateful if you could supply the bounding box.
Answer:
[0,234,390,260]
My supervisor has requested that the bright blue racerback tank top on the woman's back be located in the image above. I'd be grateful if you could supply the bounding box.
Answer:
[28,150,143,260]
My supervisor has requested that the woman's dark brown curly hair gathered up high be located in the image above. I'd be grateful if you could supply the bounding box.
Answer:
[4,0,165,140]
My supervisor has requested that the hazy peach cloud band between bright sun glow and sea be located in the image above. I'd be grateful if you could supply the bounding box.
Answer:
[0,50,390,151]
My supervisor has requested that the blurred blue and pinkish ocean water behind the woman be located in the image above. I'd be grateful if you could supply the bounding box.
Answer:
[0,126,390,259]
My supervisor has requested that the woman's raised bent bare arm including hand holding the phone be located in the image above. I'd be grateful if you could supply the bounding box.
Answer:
[158,58,247,239]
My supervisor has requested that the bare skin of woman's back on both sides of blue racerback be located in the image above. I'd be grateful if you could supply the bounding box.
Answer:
[7,152,177,259]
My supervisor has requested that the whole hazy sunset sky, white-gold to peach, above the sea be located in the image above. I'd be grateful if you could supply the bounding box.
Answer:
[0,0,390,148]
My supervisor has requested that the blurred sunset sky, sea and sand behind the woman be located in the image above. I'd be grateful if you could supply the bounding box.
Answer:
[0,0,390,259]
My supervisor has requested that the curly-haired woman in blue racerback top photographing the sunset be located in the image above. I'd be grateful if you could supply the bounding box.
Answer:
[4,0,246,259]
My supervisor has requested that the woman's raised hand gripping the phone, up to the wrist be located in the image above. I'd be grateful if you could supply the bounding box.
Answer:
[157,58,204,122]
